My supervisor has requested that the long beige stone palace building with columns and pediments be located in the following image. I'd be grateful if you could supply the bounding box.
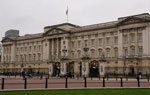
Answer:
[0,13,150,77]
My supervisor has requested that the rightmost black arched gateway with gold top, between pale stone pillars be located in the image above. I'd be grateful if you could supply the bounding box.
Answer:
[89,60,99,77]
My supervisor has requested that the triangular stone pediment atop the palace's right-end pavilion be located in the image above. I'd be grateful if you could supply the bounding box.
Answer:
[118,17,146,26]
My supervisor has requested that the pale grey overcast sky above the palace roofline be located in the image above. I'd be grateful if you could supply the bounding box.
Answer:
[0,0,150,40]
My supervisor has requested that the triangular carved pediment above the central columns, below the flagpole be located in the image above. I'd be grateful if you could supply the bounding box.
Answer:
[43,28,68,35]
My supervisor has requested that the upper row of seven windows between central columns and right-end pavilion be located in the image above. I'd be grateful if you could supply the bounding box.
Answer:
[72,37,118,48]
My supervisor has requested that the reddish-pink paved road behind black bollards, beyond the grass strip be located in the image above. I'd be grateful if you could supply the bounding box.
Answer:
[0,77,150,91]
